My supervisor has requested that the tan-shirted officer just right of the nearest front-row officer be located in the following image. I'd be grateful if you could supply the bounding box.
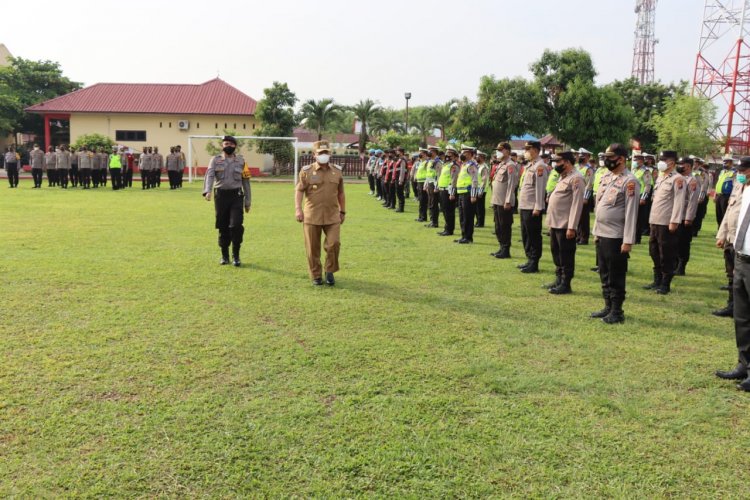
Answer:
[644,151,686,295]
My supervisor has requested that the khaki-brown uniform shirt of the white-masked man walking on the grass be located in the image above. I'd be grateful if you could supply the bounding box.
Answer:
[297,162,344,226]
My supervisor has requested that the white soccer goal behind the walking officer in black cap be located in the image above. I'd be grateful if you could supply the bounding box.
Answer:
[186,136,299,182]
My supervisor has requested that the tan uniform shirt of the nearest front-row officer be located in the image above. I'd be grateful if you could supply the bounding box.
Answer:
[593,170,641,245]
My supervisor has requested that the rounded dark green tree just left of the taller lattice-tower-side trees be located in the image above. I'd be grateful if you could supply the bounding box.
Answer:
[553,79,635,151]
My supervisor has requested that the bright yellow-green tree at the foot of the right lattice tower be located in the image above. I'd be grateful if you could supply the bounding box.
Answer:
[651,95,717,156]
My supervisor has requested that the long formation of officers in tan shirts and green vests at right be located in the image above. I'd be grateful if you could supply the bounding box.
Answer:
[367,141,750,323]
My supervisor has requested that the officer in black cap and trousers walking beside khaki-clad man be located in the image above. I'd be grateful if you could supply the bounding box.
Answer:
[203,135,251,267]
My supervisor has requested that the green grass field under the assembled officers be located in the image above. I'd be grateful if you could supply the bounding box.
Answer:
[0,181,750,498]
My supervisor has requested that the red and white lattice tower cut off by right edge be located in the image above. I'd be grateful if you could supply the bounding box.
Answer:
[693,0,750,154]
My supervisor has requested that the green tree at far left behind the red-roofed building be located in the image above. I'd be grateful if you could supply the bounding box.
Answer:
[0,57,81,142]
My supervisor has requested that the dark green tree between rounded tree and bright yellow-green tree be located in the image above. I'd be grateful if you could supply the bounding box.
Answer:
[607,78,687,152]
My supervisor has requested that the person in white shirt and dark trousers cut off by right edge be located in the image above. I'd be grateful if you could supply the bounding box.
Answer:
[716,157,750,391]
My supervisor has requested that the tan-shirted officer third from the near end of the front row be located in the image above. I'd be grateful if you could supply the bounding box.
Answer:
[518,141,548,273]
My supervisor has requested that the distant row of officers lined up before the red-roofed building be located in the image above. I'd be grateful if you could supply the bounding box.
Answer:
[3,144,186,190]
